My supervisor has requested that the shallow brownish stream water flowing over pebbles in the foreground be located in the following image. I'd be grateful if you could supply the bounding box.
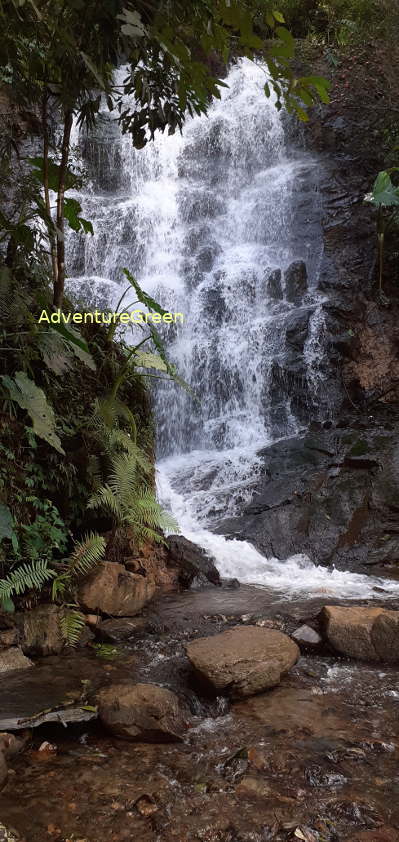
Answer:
[0,587,399,842]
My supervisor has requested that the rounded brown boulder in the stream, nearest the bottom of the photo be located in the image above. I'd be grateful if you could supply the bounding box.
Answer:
[97,684,185,742]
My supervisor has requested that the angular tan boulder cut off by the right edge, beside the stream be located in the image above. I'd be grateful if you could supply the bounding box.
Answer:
[321,605,399,662]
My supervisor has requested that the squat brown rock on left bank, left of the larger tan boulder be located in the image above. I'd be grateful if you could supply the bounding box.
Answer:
[15,605,64,656]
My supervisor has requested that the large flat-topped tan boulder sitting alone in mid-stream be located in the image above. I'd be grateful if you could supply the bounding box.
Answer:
[187,626,299,699]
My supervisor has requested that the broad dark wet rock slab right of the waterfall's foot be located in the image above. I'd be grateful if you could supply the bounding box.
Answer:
[215,426,399,573]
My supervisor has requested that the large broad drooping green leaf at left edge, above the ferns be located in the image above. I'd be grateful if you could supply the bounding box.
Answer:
[1,371,65,455]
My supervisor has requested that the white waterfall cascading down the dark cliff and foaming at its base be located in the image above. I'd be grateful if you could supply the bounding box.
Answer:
[69,60,397,598]
